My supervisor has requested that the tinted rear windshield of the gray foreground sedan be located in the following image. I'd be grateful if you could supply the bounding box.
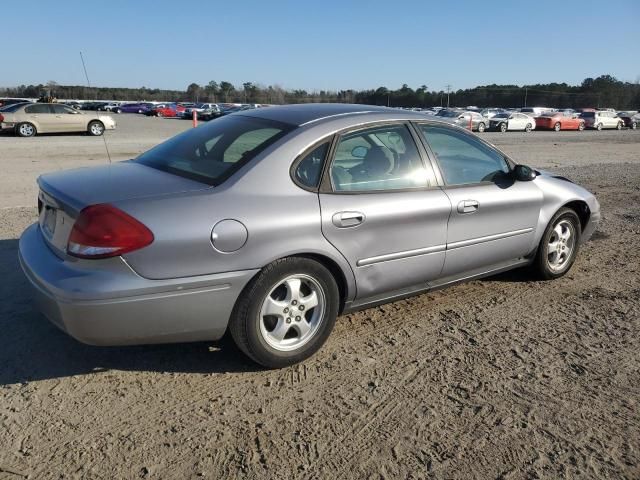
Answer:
[136,116,293,186]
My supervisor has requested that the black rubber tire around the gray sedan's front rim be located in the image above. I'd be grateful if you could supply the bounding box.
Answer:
[532,207,582,280]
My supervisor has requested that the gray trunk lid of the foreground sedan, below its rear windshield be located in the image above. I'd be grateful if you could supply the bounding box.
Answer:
[38,161,212,256]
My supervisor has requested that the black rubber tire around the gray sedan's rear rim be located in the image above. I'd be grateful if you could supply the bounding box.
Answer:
[229,257,340,368]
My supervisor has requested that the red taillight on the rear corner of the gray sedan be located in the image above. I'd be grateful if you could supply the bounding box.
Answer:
[67,204,153,258]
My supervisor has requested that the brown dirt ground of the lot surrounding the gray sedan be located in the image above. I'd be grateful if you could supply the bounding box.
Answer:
[0,115,640,479]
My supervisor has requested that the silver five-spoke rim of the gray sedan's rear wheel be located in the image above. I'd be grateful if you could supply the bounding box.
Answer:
[259,274,326,352]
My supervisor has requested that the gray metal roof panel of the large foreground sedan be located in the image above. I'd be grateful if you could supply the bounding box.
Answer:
[235,103,425,126]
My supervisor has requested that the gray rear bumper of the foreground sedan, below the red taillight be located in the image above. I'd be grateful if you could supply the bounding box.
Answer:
[19,225,257,345]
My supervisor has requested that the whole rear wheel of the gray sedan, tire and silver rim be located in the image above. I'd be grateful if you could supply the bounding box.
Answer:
[229,257,340,368]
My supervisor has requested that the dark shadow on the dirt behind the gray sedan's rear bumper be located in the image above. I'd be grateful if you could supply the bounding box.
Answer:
[0,239,261,385]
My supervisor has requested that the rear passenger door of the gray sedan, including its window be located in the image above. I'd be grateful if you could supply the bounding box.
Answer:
[319,123,451,300]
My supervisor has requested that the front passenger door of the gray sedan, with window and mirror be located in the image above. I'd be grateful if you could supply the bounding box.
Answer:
[418,124,543,277]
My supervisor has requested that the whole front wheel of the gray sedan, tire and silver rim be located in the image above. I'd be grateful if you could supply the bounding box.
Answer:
[533,208,581,280]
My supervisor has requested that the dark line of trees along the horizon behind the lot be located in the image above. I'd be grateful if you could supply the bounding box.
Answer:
[0,75,640,110]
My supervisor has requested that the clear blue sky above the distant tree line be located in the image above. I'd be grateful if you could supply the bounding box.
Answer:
[0,0,640,91]
